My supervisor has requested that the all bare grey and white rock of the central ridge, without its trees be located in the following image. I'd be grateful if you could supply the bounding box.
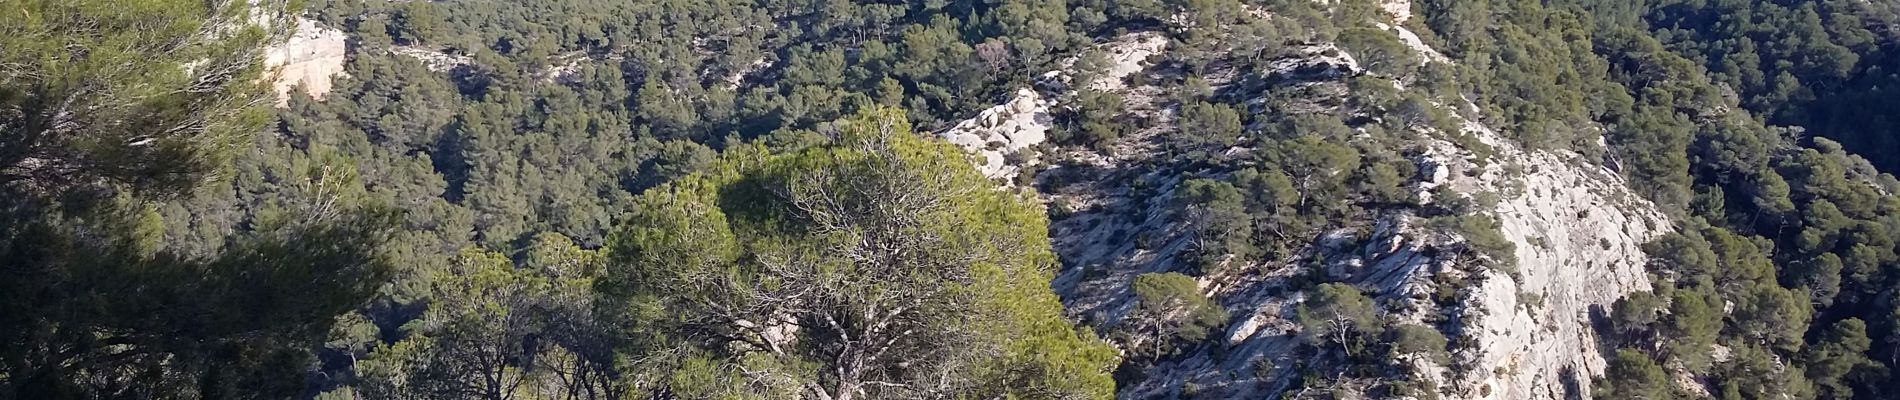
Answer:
[944,2,1672,398]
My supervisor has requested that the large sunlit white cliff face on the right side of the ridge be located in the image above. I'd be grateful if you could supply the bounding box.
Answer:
[1431,115,1670,400]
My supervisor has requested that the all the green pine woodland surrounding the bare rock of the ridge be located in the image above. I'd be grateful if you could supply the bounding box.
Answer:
[11,0,1900,400]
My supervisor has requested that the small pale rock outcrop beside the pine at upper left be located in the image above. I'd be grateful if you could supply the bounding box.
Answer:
[264,17,348,106]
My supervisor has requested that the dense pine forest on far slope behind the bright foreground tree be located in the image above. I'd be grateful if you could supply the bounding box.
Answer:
[271,0,1123,252]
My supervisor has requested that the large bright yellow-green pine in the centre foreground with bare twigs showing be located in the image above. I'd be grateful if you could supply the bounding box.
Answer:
[602,108,1115,400]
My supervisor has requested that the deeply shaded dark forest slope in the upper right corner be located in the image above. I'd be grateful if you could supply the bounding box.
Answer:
[1623,2,1900,167]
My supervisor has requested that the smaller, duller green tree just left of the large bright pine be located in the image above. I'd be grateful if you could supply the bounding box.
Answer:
[355,233,619,398]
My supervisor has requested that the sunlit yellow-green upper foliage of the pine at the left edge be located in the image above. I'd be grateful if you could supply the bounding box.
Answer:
[0,0,285,193]
